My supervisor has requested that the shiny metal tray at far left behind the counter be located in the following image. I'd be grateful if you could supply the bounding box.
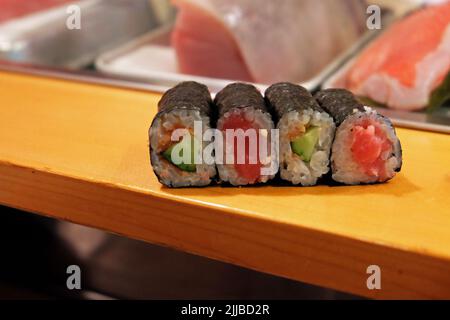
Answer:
[0,0,165,68]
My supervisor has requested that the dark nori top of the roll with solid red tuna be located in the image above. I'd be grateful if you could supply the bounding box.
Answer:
[214,83,268,117]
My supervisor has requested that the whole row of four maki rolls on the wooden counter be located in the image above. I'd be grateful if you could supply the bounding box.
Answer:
[149,82,402,187]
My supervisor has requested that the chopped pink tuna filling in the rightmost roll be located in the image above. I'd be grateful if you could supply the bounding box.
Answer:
[351,119,392,181]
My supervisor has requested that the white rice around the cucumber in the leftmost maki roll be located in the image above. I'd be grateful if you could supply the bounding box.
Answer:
[149,109,216,187]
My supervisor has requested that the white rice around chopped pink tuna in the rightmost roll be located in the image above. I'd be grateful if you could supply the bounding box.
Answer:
[331,108,402,185]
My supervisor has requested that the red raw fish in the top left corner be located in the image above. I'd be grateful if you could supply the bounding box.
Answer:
[0,0,73,23]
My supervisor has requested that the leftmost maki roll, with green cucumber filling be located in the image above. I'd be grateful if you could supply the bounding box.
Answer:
[149,82,216,187]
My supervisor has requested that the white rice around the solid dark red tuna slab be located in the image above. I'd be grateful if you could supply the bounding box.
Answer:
[217,108,276,186]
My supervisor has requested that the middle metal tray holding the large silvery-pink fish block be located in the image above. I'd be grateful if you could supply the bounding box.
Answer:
[95,0,401,93]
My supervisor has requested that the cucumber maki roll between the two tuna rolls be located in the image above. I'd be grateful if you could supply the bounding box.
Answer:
[265,83,335,186]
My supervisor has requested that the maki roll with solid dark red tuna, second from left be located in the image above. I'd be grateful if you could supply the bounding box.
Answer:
[214,83,278,186]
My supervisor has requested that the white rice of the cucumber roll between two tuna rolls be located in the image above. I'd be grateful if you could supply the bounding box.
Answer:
[277,110,335,186]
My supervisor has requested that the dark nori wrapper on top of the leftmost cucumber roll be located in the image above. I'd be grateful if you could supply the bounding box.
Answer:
[157,81,213,116]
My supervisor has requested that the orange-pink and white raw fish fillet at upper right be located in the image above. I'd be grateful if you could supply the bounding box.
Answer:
[333,2,450,110]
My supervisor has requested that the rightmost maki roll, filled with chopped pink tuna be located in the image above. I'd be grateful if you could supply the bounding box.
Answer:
[315,89,402,185]
